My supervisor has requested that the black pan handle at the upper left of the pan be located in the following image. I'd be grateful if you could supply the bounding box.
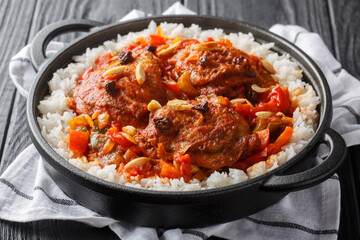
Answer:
[30,19,104,71]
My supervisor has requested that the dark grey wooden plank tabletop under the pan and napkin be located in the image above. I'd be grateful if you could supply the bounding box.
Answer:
[0,0,360,240]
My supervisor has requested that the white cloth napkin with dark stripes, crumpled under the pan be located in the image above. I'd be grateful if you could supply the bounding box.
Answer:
[0,3,360,240]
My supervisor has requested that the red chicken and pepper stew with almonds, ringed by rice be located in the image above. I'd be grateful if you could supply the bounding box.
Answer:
[69,31,293,184]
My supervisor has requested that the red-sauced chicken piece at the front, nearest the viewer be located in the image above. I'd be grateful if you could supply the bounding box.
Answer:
[136,97,260,170]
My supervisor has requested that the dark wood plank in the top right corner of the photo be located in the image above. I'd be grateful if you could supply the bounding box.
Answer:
[328,0,360,80]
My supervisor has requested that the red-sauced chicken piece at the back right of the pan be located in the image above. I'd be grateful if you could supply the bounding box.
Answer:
[165,40,273,99]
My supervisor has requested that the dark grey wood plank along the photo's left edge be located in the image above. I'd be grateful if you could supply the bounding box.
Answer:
[0,0,35,165]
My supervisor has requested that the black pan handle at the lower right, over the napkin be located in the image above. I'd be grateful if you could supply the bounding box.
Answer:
[261,128,347,191]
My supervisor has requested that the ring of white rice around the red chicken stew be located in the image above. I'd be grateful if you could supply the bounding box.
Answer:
[38,22,320,191]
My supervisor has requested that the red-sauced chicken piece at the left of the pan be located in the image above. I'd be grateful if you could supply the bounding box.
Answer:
[73,50,166,127]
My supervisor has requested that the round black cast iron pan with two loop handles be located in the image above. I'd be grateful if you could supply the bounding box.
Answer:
[27,15,346,228]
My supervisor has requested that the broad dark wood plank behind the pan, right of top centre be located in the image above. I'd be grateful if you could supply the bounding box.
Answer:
[184,0,334,54]
